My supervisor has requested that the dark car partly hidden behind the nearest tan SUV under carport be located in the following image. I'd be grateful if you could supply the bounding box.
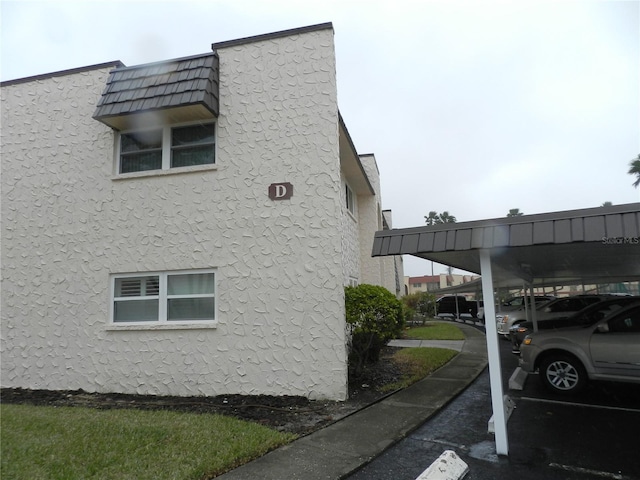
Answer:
[509,296,640,353]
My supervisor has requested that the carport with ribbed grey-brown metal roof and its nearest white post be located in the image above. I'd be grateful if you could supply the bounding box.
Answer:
[372,203,640,455]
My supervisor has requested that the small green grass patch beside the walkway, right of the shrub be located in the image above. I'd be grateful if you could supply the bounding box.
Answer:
[382,347,458,392]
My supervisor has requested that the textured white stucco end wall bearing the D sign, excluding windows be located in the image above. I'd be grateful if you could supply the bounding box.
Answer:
[1,29,347,399]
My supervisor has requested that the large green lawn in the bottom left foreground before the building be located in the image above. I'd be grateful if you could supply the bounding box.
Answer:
[0,404,296,480]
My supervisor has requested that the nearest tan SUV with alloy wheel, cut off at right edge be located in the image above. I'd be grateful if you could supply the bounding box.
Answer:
[519,302,640,394]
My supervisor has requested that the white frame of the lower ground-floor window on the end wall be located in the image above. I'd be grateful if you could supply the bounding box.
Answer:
[108,268,218,330]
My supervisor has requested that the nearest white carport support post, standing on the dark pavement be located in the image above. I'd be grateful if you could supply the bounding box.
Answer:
[480,249,509,455]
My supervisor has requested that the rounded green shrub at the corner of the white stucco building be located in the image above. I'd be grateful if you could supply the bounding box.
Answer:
[345,284,404,377]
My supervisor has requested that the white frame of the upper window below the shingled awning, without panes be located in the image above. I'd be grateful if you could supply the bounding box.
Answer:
[114,121,218,177]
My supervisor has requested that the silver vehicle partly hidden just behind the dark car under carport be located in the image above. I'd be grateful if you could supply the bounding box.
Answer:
[496,295,607,340]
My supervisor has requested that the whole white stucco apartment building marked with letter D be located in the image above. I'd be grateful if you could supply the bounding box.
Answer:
[1,24,403,400]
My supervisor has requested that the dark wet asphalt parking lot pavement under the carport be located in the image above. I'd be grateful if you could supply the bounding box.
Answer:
[348,334,640,480]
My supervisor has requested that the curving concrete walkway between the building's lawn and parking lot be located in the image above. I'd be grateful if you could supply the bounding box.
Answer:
[217,324,487,480]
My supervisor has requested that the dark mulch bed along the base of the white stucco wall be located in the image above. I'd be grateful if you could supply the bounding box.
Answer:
[0,347,404,435]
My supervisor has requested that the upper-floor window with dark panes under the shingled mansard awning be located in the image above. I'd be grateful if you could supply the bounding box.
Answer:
[118,123,215,173]
